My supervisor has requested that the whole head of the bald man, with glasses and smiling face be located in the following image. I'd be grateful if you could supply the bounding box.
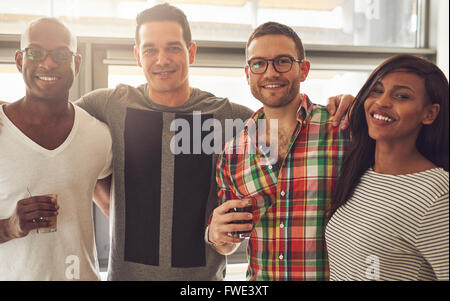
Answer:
[15,18,81,101]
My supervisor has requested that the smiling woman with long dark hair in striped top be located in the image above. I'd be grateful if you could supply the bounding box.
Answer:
[326,55,449,280]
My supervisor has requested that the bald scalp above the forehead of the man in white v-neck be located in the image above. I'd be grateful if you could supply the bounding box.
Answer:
[20,17,77,53]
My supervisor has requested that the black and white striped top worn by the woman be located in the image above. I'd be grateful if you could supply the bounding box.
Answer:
[325,168,449,280]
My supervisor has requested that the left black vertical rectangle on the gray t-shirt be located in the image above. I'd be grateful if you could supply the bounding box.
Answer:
[124,108,163,266]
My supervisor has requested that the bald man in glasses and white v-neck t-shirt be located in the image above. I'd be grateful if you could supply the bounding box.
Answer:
[0,18,112,280]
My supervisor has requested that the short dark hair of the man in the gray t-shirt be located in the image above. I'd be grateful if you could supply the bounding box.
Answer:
[135,3,192,47]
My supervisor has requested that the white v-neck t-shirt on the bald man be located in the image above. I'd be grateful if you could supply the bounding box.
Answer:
[0,106,112,280]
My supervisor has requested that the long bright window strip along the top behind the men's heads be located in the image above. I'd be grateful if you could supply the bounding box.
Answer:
[0,0,423,47]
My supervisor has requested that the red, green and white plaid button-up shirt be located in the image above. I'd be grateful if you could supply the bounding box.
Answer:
[216,95,350,280]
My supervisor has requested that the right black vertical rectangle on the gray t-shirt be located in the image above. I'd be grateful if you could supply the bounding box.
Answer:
[172,114,213,268]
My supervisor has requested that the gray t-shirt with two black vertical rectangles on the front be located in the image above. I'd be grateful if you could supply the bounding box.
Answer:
[76,84,252,280]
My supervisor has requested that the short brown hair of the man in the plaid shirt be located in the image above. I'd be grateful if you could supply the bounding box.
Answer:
[245,22,306,60]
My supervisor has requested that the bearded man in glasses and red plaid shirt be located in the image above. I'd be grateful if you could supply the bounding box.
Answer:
[208,22,350,280]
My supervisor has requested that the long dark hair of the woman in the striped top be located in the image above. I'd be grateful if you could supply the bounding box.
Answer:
[331,54,449,214]
